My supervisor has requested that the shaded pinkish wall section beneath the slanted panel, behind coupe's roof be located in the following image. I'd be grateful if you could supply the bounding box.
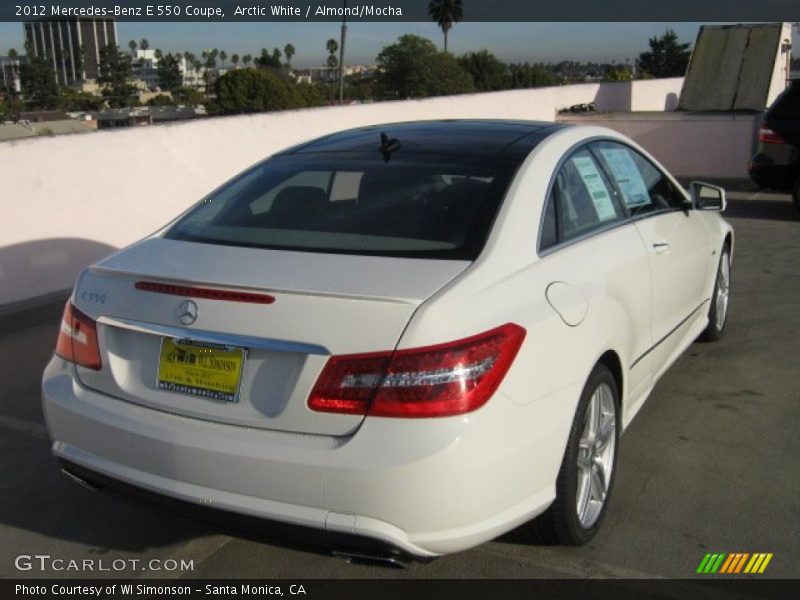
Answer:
[559,113,760,180]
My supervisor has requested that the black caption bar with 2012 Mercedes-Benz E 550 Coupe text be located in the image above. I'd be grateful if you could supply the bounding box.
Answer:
[0,0,800,22]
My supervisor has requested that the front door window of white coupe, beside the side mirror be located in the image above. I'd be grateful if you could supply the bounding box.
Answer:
[592,142,684,216]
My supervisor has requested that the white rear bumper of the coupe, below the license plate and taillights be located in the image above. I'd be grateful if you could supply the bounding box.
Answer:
[42,358,579,557]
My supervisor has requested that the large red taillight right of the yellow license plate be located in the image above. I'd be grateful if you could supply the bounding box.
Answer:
[308,323,525,417]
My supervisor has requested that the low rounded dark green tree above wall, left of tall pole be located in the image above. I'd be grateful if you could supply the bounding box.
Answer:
[215,69,303,114]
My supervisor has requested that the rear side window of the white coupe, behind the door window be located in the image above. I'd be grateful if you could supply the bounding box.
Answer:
[539,148,624,250]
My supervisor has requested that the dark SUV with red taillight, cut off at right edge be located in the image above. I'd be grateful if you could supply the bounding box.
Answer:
[748,79,800,209]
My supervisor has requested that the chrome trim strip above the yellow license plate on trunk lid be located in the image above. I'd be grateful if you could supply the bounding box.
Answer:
[97,316,331,356]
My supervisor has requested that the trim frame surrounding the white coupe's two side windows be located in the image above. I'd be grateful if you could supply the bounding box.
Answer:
[536,136,694,258]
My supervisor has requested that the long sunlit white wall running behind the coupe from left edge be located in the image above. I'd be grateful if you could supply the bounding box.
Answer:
[0,80,680,307]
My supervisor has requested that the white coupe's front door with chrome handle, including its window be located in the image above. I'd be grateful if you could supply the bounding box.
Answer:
[592,141,710,375]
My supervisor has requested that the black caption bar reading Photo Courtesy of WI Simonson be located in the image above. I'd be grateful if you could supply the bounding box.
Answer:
[0,578,798,600]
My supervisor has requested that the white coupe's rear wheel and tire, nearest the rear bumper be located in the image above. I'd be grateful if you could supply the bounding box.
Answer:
[532,364,619,546]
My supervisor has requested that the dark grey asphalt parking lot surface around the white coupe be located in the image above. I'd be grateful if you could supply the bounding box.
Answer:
[0,193,800,579]
